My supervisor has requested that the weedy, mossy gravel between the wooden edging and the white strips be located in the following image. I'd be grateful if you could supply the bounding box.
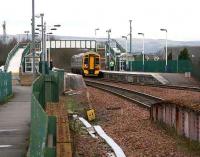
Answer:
[60,89,110,157]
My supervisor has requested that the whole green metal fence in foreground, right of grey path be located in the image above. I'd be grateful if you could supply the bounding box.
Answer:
[28,70,64,157]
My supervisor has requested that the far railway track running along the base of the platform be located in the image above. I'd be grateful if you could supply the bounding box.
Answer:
[92,79,200,92]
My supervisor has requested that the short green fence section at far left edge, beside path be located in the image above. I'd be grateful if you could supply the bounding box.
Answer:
[0,72,12,102]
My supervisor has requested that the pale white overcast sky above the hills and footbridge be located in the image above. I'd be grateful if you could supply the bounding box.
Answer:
[0,0,200,40]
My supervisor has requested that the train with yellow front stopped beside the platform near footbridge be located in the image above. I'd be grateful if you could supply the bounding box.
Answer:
[71,51,100,76]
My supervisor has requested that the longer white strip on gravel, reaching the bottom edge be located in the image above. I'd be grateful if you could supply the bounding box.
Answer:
[94,125,126,157]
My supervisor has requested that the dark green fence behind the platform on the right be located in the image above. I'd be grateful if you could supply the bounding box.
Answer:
[129,60,192,73]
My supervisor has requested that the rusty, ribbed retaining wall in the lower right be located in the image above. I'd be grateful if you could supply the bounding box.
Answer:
[151,103,200,142]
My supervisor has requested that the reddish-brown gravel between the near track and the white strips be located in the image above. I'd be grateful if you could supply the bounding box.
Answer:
[88,85,199,157]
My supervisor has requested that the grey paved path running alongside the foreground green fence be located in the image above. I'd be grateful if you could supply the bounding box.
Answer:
[0,86,31,157]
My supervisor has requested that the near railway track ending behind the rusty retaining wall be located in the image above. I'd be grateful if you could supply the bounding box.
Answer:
[85,79,164,108]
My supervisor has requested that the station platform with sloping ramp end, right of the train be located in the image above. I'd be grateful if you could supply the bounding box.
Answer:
[101,70,200,87]
